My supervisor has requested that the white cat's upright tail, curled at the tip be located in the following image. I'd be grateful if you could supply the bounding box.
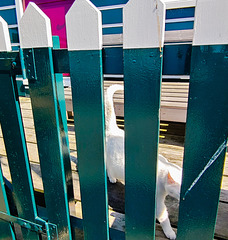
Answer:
[105,84,124,131]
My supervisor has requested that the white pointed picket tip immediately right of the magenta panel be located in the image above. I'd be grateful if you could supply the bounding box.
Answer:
[66,0,102,50]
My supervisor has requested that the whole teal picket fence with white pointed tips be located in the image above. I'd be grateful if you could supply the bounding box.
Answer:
[0,0,228,240]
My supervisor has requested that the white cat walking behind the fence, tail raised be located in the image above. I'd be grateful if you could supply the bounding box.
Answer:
[105,85,182,239]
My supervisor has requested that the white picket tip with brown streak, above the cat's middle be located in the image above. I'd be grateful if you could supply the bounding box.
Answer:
[123,0,165,49]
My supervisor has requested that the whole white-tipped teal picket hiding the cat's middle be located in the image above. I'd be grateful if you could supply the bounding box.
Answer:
[123,0,165,240]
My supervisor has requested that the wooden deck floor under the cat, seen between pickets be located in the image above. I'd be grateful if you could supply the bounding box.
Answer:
[0,97,228,240]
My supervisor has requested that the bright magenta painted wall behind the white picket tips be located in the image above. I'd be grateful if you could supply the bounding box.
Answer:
[24,0,74,48]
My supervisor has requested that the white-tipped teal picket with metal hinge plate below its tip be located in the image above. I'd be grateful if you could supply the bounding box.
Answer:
[19,3,71,239]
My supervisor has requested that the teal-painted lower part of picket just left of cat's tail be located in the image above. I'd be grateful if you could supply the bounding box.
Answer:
[69,50,109,240]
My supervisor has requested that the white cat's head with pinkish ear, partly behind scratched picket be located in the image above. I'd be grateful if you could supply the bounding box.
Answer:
[165,169,182,200]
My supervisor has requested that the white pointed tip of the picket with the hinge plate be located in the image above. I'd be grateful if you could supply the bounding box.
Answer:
[19,3,53,48]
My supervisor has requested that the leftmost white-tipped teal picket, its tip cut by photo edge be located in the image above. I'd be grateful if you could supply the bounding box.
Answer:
[0,17,39,239]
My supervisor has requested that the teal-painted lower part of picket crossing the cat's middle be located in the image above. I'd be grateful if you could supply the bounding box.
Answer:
[124,48,162,240]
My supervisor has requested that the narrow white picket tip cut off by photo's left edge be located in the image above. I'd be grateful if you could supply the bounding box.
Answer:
[0,16,11,52]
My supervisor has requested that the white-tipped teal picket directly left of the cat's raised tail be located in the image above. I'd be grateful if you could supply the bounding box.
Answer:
[66,0,109,240]
